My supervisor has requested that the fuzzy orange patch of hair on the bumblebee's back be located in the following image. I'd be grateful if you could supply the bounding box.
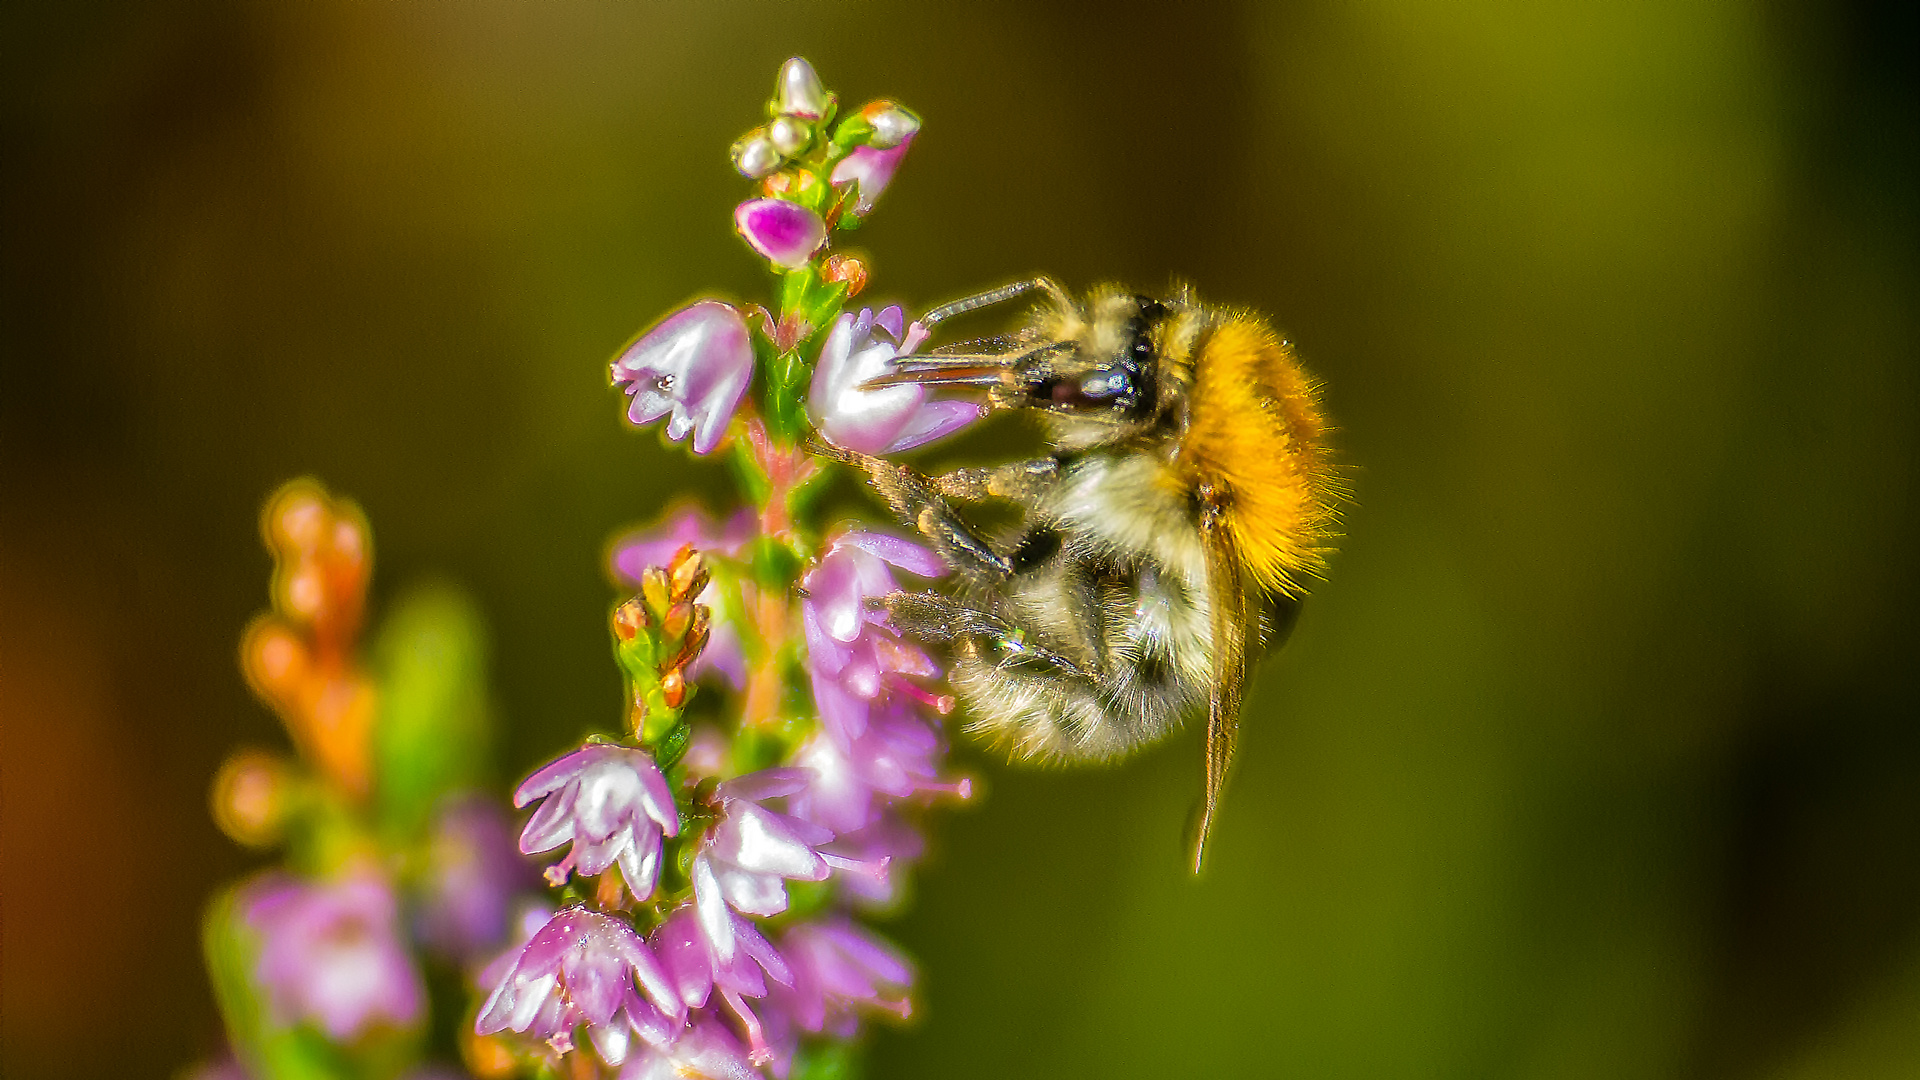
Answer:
[1181,317,1332,596]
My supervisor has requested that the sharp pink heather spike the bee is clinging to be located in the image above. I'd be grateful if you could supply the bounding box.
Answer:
[472,60,979,1080]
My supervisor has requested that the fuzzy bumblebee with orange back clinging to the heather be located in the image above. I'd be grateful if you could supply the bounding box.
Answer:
[822,279,1336,871]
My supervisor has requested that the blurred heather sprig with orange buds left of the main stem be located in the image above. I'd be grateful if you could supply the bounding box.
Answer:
[202,480,538,1080]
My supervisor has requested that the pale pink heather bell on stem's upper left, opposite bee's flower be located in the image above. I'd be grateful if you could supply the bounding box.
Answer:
[612,300,753,454]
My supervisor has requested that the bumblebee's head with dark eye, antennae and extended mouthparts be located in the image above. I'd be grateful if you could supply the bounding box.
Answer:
[870,282,1187,448]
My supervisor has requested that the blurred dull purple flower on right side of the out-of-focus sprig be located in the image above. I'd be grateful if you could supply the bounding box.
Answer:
[419,798,538,959]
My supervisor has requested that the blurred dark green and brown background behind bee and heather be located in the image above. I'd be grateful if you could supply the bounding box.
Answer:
[0,0,1920,1080]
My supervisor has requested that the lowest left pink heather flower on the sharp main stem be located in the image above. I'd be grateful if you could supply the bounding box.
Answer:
[474,907,685,1040]
